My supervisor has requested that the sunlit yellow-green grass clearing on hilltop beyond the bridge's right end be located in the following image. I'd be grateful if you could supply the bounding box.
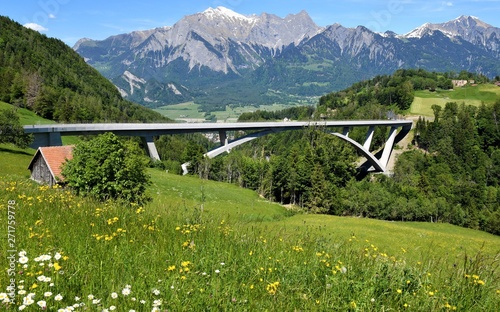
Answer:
[410,84,500,117]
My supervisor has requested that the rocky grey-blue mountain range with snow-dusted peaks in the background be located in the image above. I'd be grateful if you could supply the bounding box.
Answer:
[74,7,500,108]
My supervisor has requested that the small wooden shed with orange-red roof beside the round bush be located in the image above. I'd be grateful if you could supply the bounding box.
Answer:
[28,145,74,186]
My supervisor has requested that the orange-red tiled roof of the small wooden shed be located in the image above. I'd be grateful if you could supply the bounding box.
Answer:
[28,145,74,181]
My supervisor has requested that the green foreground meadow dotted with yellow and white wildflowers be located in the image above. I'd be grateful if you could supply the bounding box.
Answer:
[0,145,500,311]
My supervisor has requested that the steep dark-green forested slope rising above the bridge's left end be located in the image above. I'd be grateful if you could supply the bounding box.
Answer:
[0,16,167,122]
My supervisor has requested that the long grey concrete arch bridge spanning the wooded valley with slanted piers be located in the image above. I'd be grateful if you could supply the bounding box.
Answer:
[24,120,412,172]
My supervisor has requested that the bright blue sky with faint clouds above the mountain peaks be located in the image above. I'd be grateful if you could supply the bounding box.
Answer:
[0,0,500,46]
